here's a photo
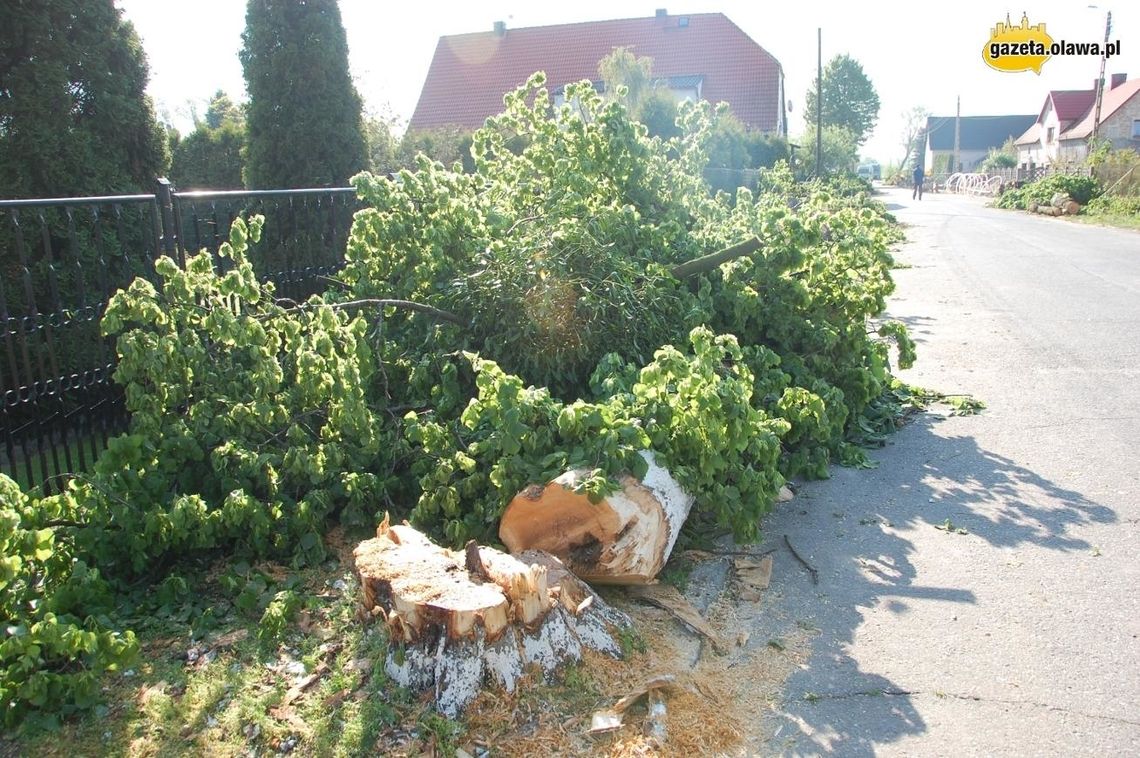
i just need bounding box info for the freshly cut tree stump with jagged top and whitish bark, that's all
[353,519,632,718]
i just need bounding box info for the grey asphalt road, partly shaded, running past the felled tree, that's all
[760,185,1140,756]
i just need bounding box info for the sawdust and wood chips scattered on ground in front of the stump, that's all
[466,594,809,758]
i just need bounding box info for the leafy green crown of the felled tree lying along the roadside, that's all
[0,75,913,722]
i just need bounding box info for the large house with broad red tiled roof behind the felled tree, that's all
[408,10,788,135]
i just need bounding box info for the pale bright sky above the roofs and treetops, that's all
[116,0,1140,164]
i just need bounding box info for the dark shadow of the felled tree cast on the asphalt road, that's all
[758,414,1117,756]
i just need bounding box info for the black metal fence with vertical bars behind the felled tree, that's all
[0,180,359,491]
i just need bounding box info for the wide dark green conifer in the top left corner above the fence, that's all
[0,0,169,197]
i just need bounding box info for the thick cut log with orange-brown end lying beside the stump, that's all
[499,451,693,585]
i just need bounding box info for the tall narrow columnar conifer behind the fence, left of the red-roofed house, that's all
[241,0,367,189]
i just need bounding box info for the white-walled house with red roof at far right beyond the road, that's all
[1017,74,1140,168]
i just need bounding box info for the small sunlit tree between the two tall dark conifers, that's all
[170,90,245,189]
